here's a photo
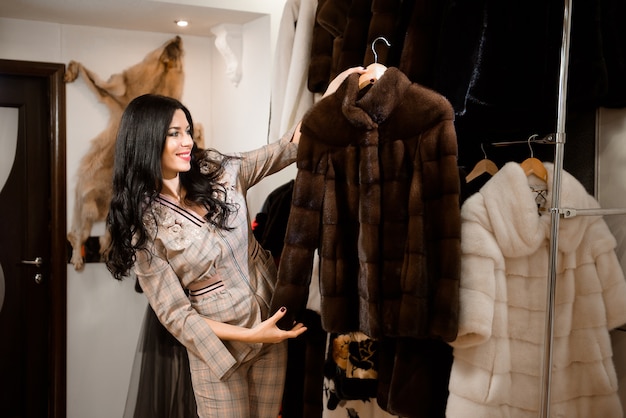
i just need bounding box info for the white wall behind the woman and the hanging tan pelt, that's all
[0,10,282,418]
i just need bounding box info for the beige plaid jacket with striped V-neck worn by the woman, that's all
[134,129,297,379]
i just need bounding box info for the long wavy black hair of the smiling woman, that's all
[106,94,237,280]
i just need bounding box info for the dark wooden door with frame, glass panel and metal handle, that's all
[0,60,67,418]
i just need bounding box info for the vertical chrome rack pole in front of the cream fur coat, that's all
[540,0,572,418]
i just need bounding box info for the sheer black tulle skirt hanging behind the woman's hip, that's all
[124,305,198,418]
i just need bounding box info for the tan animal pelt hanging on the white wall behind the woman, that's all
[65,36,184,270]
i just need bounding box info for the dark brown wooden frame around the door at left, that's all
[0,59,67,418]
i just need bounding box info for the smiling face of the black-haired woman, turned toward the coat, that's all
[161,109,193,180]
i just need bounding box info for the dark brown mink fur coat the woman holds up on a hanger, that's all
[272,67,460,417]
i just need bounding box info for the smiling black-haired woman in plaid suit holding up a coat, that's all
[107,67,363,417]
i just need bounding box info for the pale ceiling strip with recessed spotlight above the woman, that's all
[0,0,266,36]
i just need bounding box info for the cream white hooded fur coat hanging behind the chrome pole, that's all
[446,162,626,418]
